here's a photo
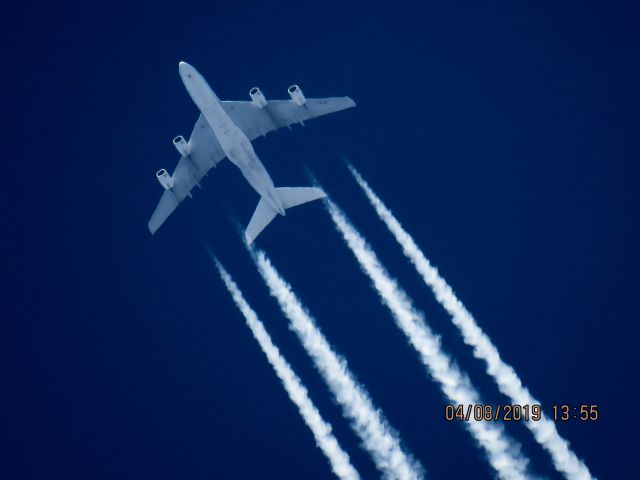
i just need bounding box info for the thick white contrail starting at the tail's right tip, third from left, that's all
[326,200,528,479]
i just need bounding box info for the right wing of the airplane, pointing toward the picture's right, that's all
[220,97,356,140]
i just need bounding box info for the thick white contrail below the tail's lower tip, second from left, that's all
[253,251,424,480]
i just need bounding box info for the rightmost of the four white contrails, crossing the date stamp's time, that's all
[348,165,592,480]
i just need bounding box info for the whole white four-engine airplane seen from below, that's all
[148,62,356,245]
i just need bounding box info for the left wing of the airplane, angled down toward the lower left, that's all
[149,115,225,233]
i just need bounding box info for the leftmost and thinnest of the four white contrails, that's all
[214,258,360,480]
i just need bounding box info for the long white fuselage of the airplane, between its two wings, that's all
[180,62,285,215]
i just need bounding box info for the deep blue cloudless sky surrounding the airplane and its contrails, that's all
[0,1,640,479]
